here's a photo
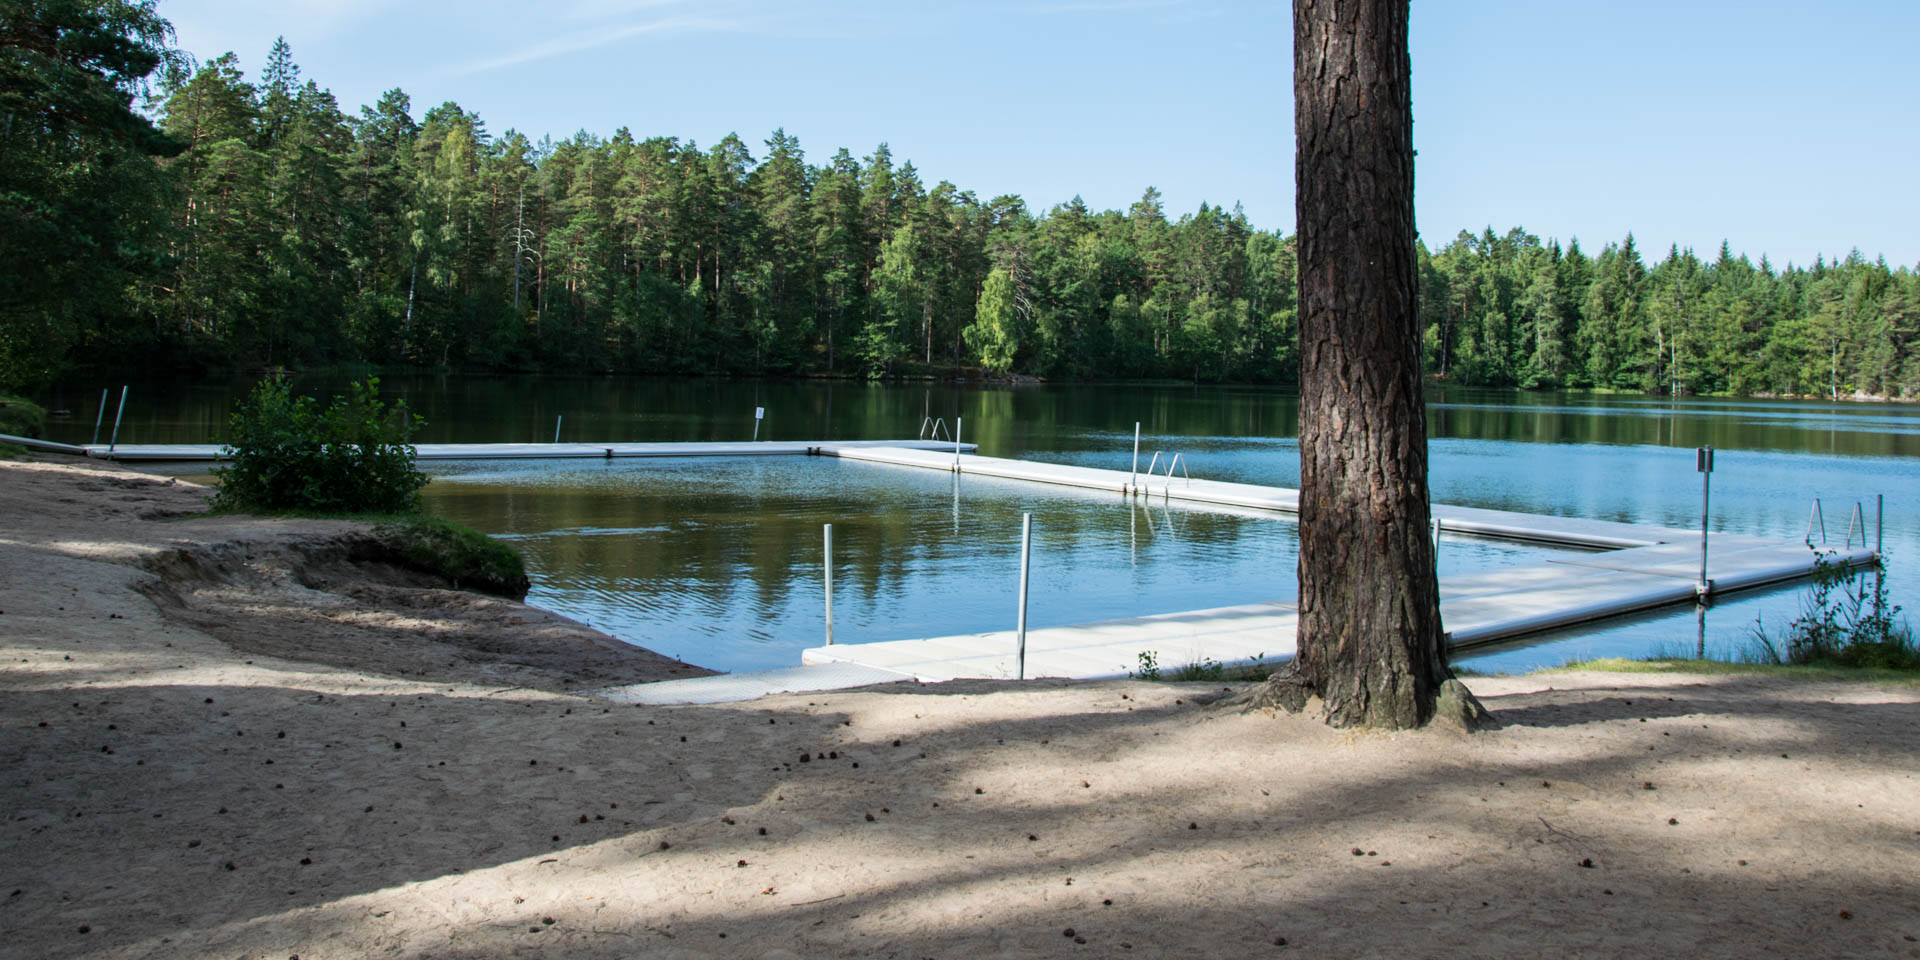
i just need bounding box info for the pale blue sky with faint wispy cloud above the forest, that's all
[159,0,1920,267]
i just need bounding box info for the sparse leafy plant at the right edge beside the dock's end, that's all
[1753,553,1920,670]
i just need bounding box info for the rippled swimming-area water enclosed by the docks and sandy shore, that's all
[428,457,1589,670]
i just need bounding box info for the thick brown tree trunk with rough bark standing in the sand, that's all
[1254,0,1443,728]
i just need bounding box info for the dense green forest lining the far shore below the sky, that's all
[0,0,1920,397]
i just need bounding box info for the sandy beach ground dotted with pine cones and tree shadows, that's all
[0,461,1920,960]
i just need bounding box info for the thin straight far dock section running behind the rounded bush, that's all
[61,440,977,461]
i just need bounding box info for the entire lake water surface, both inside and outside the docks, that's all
[42,376,1920,670]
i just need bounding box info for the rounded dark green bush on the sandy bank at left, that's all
[215,376,426,513]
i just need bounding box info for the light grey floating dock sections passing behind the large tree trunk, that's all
[601,444,1876,703]
